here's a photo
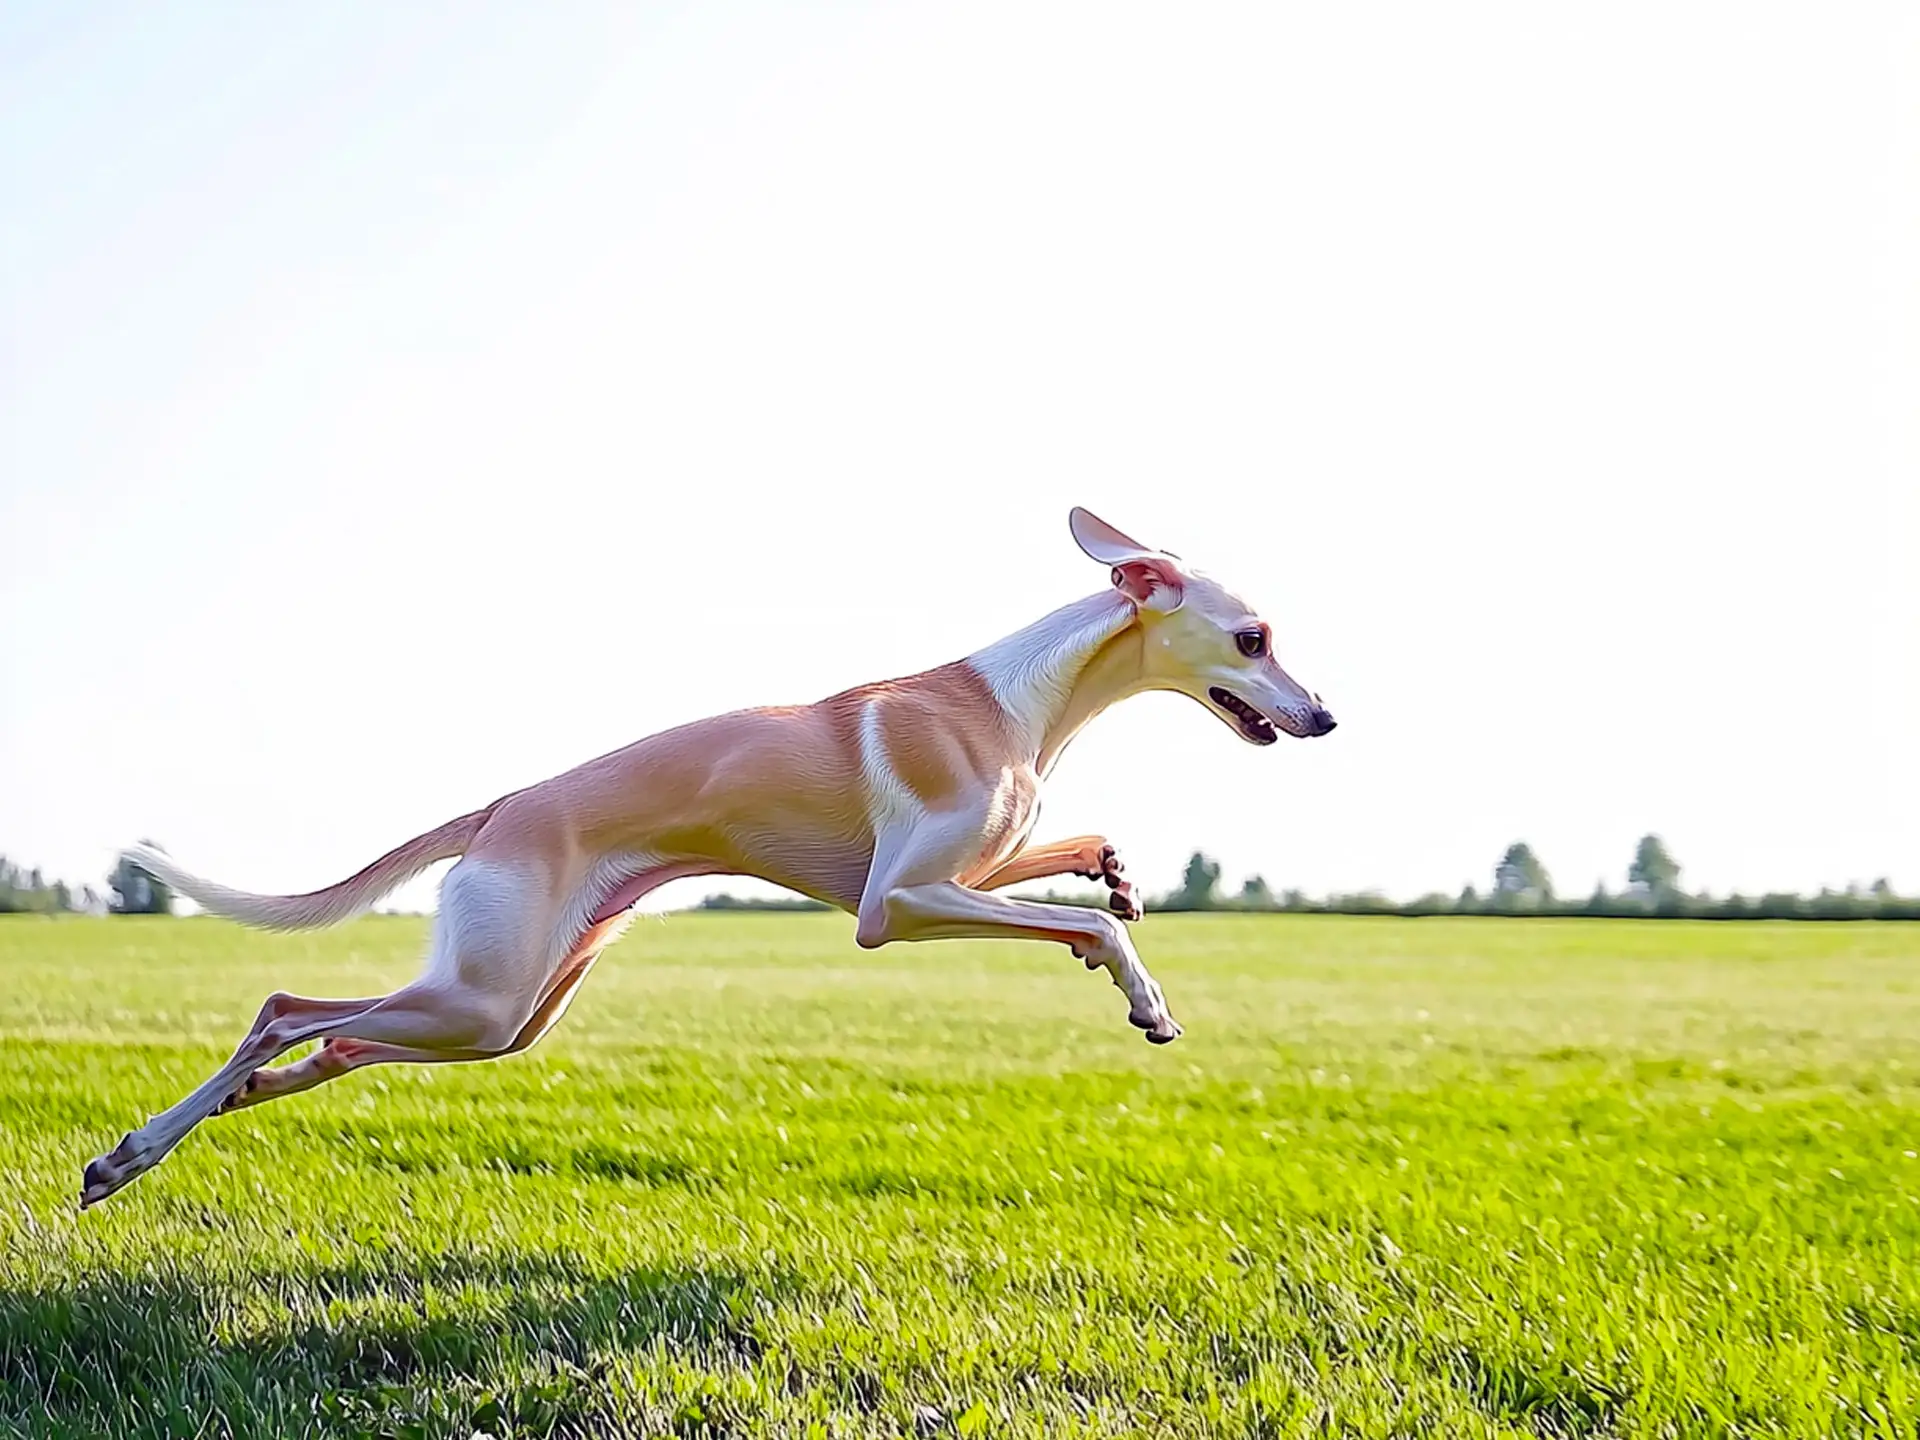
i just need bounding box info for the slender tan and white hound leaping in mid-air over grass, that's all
[81,509,1334,1210]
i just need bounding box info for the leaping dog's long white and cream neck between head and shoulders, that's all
[966,589,1144,776]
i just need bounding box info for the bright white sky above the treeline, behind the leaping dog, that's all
[0,2,1920,904]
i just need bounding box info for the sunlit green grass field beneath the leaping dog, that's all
[0,916,1920,1440]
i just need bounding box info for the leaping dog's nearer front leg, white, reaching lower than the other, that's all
[858,872,1181,1044]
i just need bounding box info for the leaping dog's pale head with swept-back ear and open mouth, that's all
[1068,505,1332,745]
